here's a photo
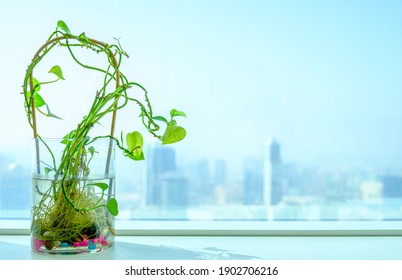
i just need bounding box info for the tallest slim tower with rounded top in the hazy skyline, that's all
[264,140,283,205]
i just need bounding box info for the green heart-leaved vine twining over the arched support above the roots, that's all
[22,21,186,243]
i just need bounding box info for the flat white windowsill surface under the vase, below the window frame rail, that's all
[0,235,402,260]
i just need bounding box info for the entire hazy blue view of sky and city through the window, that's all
[0,0,402,221]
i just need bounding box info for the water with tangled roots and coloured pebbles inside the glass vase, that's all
[31,176,115,254]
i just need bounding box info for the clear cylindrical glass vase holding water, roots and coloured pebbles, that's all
[31,138,117,255]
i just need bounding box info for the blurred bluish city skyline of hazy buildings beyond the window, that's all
[0,141,402,220]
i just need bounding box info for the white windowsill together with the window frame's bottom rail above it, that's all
[0,220,402,260]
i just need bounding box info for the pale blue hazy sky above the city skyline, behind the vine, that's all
[0,0,402,173]
